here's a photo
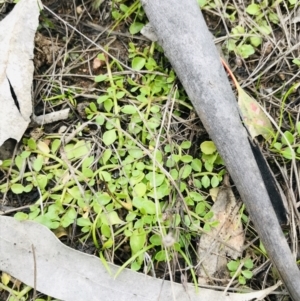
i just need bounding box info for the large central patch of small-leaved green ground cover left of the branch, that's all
[0,36,224,281]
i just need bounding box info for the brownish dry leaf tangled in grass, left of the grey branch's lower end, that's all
[198,176,245,284]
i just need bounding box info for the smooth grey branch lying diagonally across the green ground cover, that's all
[141,0,300,301]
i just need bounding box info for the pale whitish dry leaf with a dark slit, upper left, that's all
[0,0,41,146]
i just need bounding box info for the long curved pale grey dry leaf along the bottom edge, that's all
[0,216,280,301]
